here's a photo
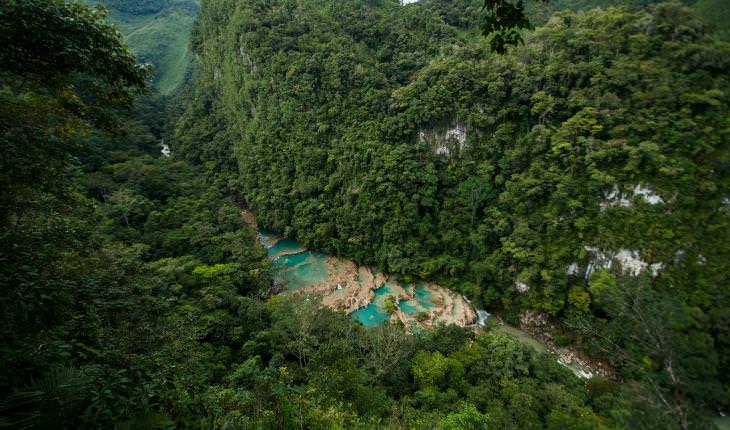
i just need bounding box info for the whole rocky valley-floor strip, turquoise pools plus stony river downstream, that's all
[241,210,616,379]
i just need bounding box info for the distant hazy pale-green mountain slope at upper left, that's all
[86,0,199,95]
